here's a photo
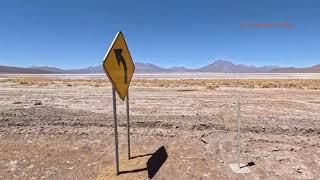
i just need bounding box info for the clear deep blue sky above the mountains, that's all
[0,0,320,69]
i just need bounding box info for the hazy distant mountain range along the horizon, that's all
[0,60,320,74]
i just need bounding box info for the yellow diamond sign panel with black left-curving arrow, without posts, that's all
[103,32,135,100]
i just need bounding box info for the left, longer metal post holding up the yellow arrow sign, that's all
[112,87,119,175]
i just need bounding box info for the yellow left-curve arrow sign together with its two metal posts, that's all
[102,32,135,175]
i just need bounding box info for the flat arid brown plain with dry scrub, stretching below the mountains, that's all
[0,74,320,180]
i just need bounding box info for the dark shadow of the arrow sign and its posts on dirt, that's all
[119,146,168,178]
